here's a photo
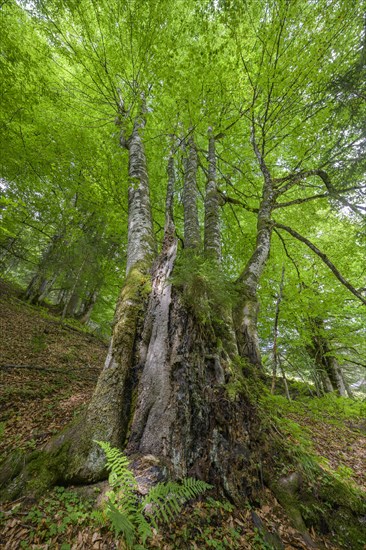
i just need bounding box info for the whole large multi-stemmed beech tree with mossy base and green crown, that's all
[0,0,366,544]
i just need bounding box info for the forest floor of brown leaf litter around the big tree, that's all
[0,281,366,550]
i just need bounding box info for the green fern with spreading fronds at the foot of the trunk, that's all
[96,441,212,550]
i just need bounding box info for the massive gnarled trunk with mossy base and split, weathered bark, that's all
[1,125,257,502]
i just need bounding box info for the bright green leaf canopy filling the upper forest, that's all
[0,0,366,383]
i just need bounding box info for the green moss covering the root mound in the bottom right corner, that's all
[260,390,366,549]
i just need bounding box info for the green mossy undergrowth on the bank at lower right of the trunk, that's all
[260,390,366,550]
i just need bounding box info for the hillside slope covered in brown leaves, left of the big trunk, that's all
[0,281,107,466]
